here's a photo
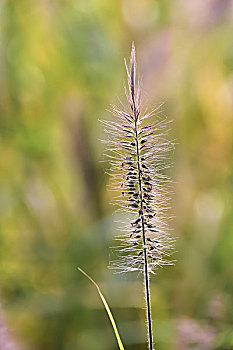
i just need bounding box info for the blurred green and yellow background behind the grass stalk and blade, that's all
[0,0,233,350]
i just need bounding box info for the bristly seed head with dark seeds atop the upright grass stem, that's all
[102,44,173,273]
